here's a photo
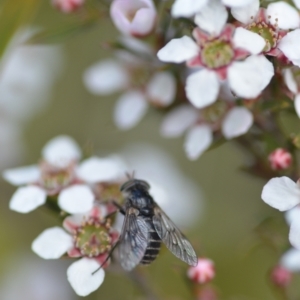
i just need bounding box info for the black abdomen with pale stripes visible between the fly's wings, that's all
[140,218,161,265]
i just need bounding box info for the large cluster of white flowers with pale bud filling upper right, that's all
[79,0,300,160]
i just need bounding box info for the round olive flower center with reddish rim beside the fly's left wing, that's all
[74,219,112,257]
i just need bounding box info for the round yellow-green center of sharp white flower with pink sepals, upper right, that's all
[201,39,234,69]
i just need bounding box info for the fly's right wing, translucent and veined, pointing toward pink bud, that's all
[153,206,198,266]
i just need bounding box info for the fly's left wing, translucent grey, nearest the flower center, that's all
[119,208,149,271]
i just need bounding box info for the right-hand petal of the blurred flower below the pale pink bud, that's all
[146,72,176,106]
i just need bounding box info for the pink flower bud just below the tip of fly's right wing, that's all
[187,258,215,284]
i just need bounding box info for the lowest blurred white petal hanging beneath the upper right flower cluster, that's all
[184,125,213,160]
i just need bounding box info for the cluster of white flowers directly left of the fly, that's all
[3,136,124,296]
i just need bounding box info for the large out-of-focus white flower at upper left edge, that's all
[0,29,62,122]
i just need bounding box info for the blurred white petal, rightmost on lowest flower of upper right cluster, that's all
[222,107,253,139]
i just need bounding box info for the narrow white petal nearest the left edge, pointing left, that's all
[3,165,40,185]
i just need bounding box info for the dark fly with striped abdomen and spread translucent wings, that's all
[118,178,198,271]
